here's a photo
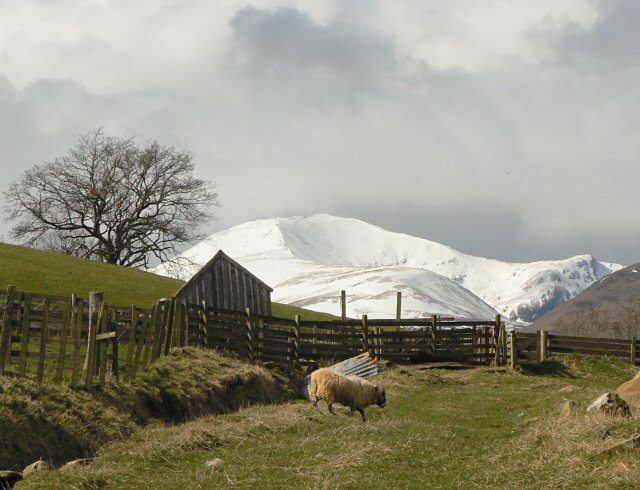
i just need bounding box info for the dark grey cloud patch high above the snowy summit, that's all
[230,7,399,103]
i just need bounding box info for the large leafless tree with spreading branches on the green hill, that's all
[4,130,219,267]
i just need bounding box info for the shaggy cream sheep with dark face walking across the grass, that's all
[309,368,387,422]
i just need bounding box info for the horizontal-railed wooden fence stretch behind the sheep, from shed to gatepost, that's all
[198,305,501,364]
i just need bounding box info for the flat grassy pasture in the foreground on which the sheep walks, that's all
[18,357,640,489]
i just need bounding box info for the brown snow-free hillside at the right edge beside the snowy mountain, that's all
[528,263,640,337]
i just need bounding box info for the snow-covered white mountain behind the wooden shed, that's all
[154,215,622,323]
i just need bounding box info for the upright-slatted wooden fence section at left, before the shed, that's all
[0,287,187,389]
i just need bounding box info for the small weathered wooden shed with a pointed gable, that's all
[176,250,273,316]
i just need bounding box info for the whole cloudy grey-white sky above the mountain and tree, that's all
[0,0,640,265]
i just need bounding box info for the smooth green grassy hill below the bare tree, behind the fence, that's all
[0,243,336,320]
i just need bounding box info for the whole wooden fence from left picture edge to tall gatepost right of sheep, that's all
[0,286,504,389]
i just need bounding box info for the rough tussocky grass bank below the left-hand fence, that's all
[0,349,284,470]
